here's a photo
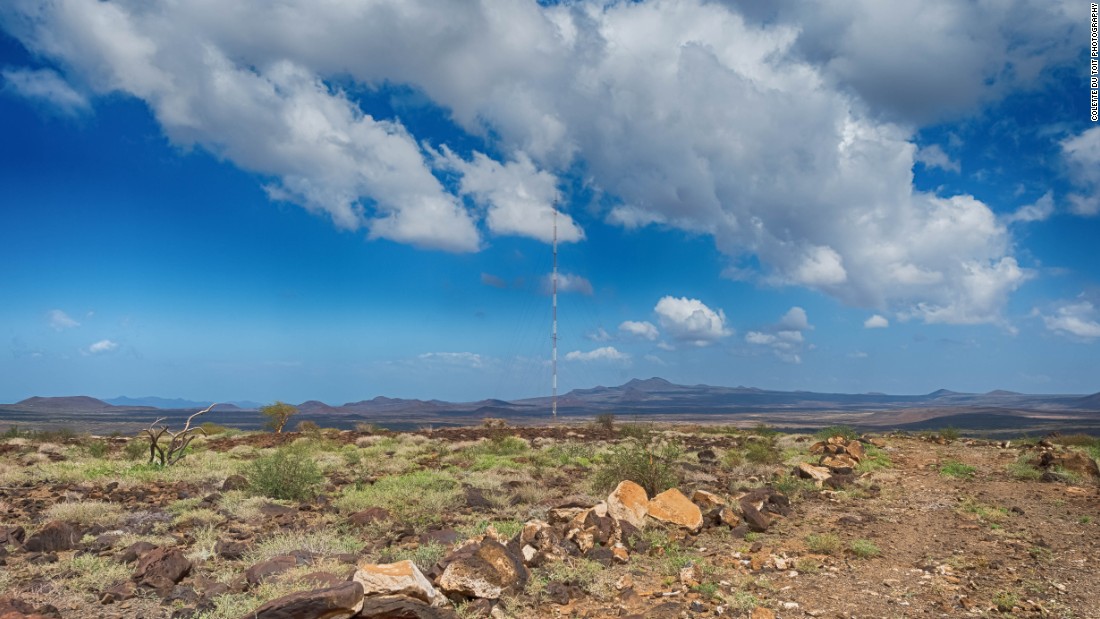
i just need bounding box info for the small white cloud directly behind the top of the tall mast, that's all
[437,146,584,243]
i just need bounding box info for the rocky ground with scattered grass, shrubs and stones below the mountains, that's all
[0,423,1100,619]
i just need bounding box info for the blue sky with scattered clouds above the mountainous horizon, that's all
[0,0,1100,404]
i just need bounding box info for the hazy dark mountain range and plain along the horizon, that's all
[0,377,1100,427]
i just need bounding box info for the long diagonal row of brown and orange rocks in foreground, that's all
[238,482,790,619]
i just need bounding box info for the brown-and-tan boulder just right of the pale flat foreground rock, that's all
[439,540,528,599]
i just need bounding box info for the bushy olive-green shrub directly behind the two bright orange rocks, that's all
[593,441,683,496]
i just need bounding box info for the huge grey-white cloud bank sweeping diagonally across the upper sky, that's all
[2,0,1064,323]
